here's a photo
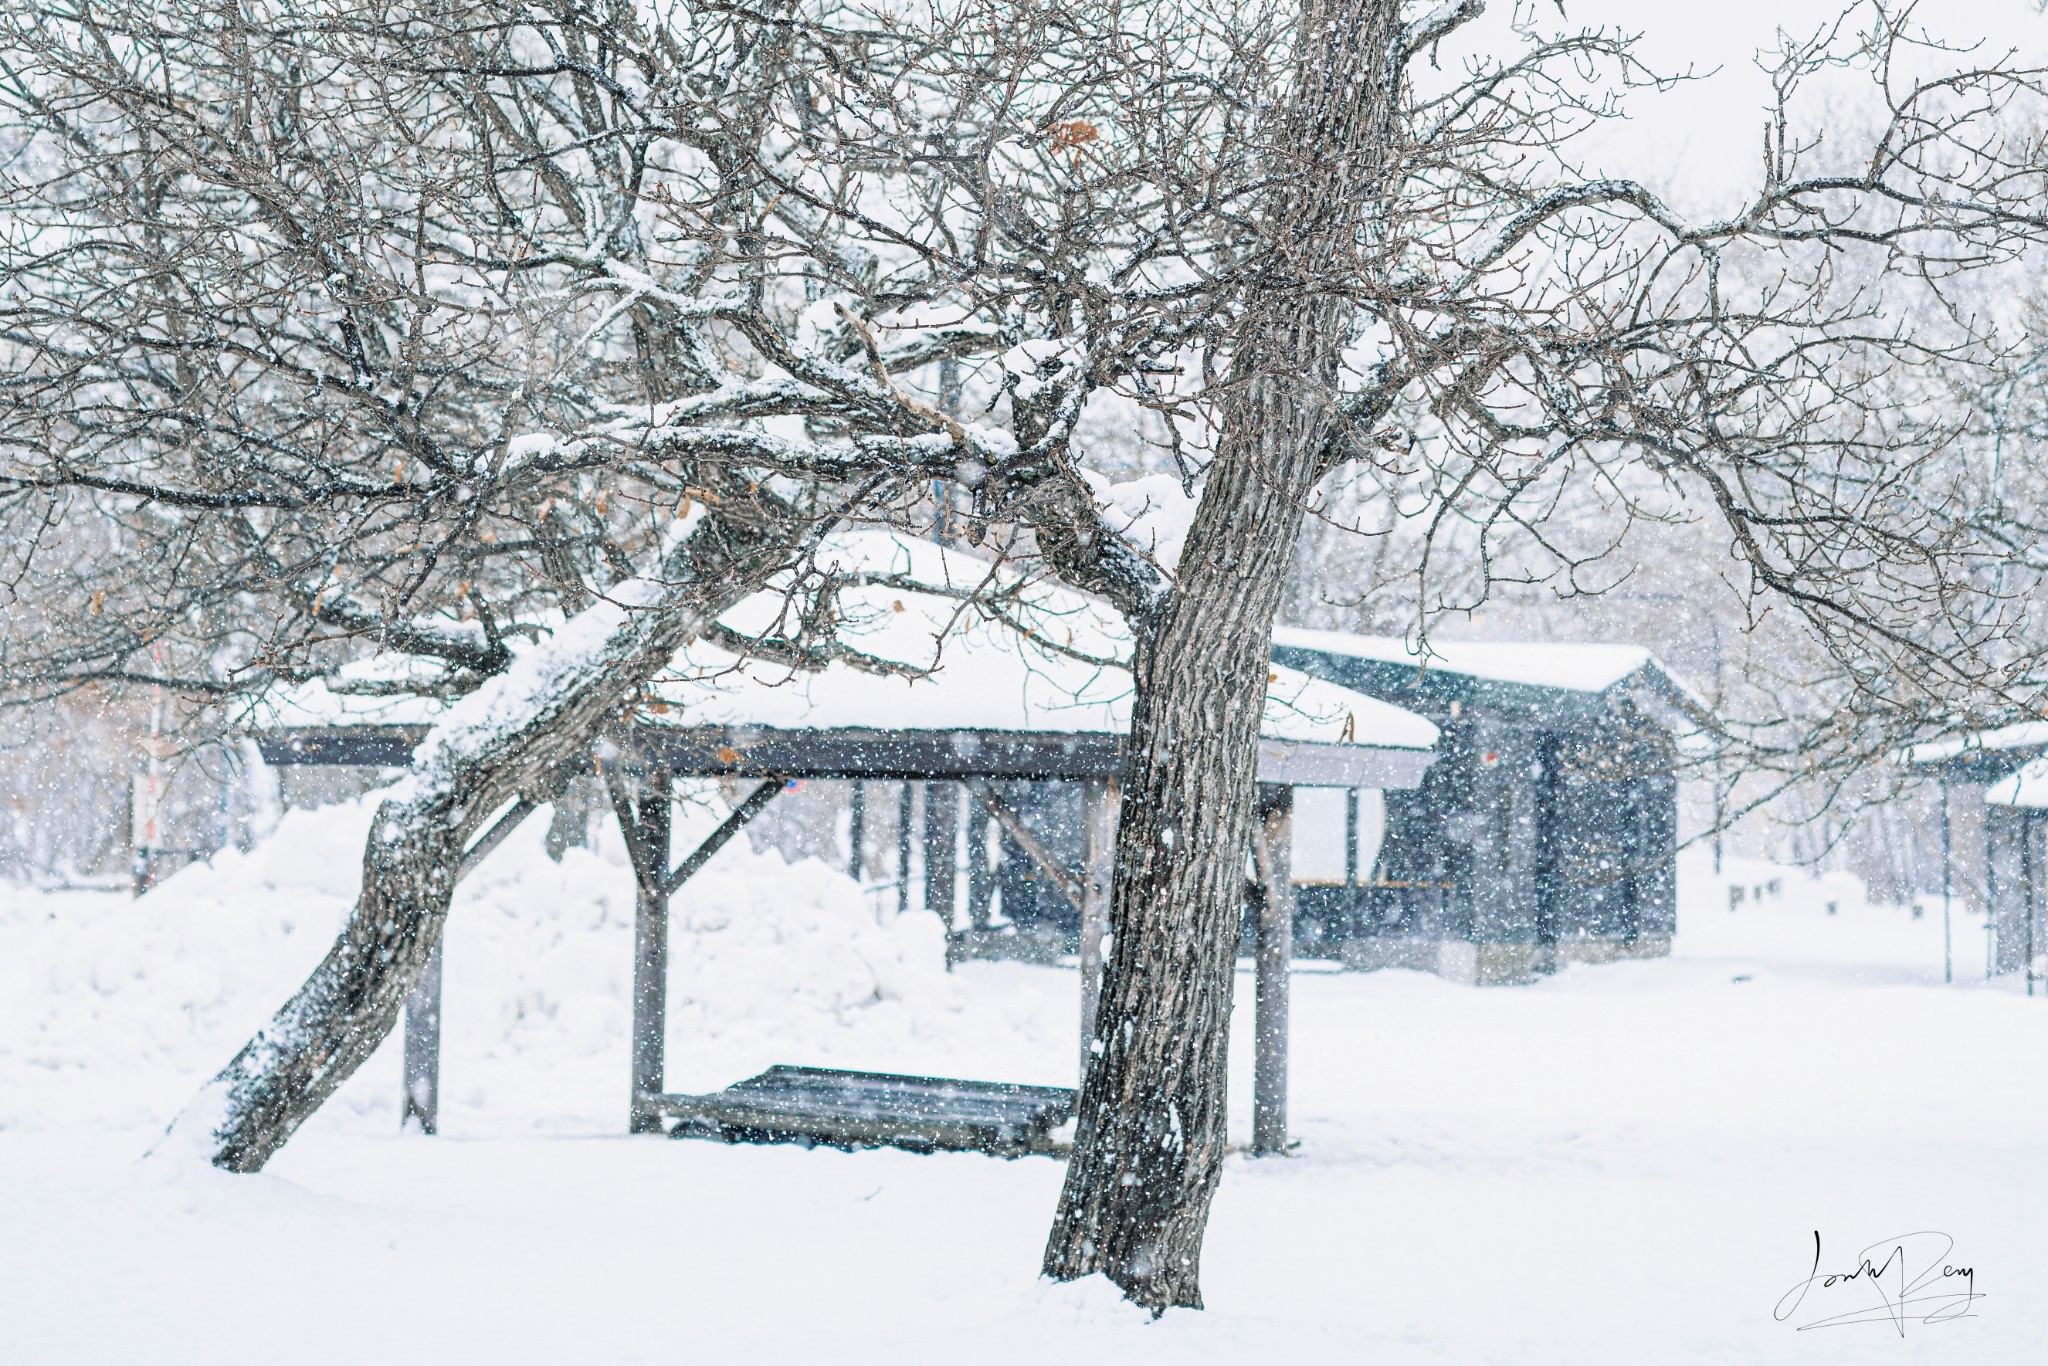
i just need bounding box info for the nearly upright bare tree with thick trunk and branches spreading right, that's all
[1019,0,2048,1309]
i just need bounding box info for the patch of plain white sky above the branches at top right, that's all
[1442,0,2048,213]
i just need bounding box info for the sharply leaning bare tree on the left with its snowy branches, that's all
[0,4,1056,1169]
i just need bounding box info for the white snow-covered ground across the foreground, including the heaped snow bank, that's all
[0,807,2048,1366]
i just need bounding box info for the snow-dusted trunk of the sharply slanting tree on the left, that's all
[172,514,784,1171]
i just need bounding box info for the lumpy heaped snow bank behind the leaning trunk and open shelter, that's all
[0,795,983,1133]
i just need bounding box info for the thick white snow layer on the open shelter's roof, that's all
[256,530,1438,750]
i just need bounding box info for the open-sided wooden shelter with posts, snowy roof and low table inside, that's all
[258,532,1436,1151]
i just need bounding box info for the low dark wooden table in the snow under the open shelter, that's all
[647,1067,1073,1157]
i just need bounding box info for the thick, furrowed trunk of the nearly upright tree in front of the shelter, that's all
[1044,0,1399,1311]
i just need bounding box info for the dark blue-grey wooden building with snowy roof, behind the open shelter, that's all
[1274,629,1700,983]
